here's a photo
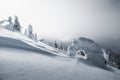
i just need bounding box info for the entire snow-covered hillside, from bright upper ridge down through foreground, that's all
[0,28,120,80]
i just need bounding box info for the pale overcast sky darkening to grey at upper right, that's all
[0,0,120,40]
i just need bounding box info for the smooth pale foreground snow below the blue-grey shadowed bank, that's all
[0,48,120,80]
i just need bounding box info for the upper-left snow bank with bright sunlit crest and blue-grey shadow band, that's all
[0,27,65,56]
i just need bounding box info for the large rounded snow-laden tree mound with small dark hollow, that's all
[67,37,105,66]
